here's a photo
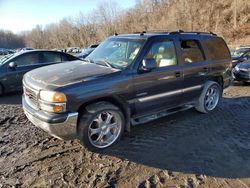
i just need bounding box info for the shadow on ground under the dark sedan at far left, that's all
[0,91,22,105]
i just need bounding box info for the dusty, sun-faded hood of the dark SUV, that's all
[24,61,119,89]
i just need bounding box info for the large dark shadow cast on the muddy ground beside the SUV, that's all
[101,97,250,178]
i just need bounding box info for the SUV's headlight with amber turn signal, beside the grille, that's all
[39,91,67,113]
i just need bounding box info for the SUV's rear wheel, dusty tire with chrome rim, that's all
[195,81,222,113]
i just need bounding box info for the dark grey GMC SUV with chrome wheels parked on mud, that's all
[23,32,231,150]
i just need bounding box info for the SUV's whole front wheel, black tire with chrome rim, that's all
[77,101,125,151]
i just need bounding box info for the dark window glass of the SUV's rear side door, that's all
[181,40,205,64]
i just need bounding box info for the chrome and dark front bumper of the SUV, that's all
[22,97,78,140]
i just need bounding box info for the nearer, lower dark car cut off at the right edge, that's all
[232,60,250,83]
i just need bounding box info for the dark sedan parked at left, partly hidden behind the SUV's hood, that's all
[0,50,79,95]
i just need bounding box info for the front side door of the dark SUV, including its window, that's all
[133,38,183,116]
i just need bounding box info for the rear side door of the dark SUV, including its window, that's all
[180,36,210,103]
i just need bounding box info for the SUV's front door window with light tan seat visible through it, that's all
[146,41,177,67]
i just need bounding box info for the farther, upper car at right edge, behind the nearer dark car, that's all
[232,47,250,67]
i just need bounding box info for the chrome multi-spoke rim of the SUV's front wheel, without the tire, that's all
[88,110,122,148]
